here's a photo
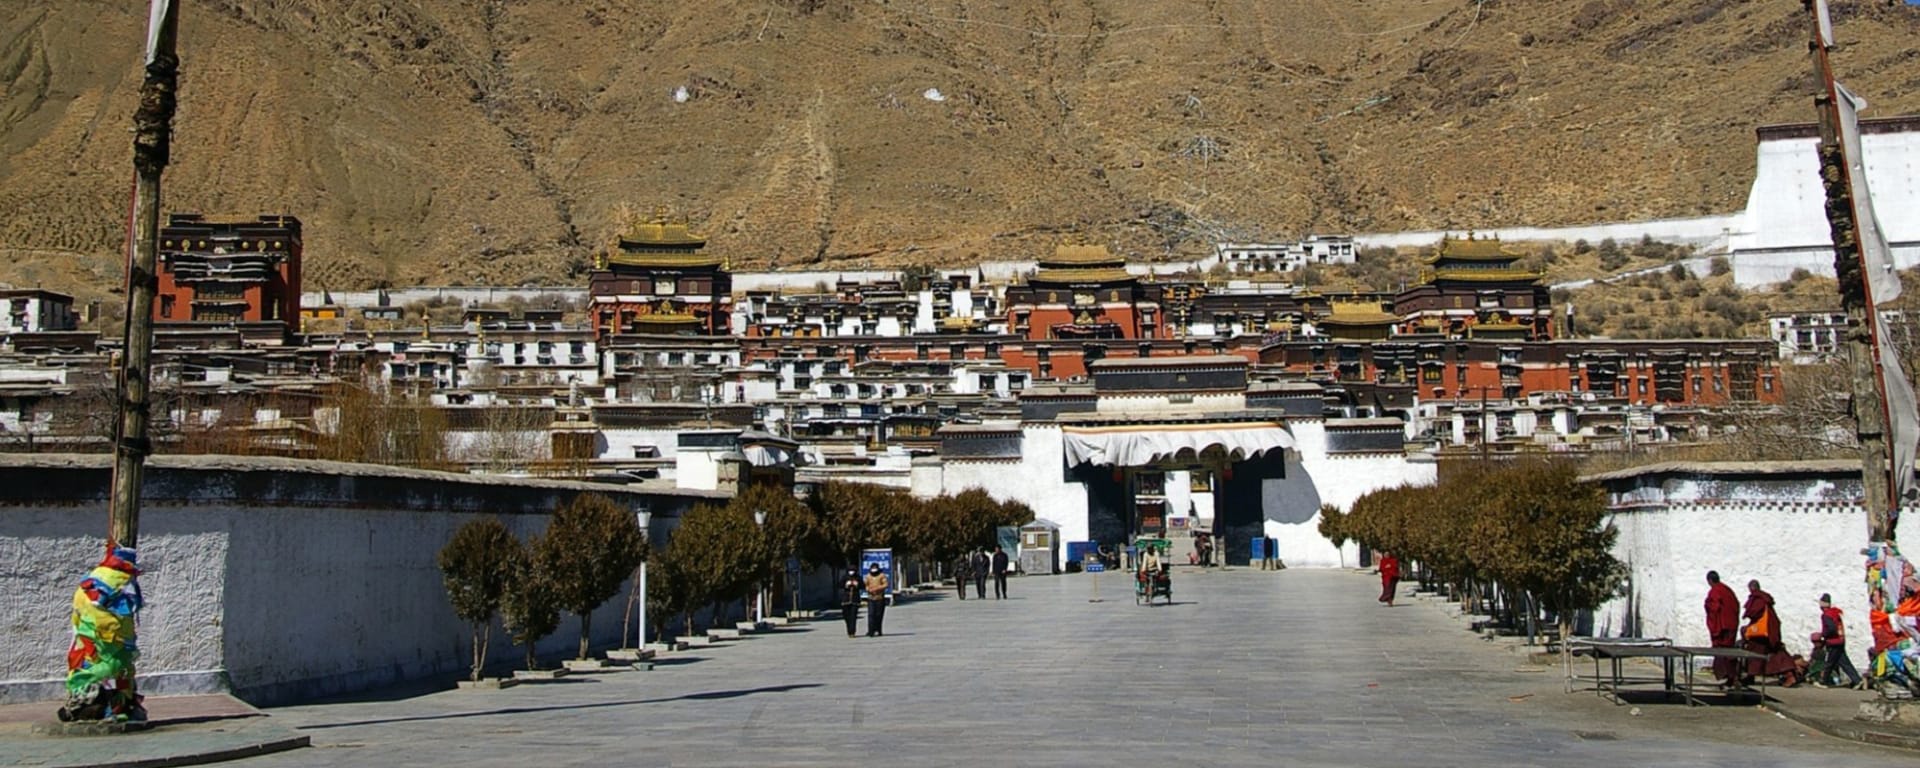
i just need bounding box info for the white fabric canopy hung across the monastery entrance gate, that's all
[1062,420,1294,467]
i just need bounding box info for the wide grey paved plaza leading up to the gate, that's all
[228,568,1912,768]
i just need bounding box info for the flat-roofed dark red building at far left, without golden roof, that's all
[154,213,300,324]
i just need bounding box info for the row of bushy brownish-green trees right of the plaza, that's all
[1319,461,1624,649]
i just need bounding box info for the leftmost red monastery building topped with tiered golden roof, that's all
[588,213,733,338]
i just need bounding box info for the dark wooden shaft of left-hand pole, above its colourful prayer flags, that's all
[108,0,180,547]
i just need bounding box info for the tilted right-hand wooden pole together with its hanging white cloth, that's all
[1803,0,1920,549]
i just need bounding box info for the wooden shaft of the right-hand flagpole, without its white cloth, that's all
[1803,0,1910,543]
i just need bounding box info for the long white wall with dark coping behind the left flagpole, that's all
[0,455,721,703]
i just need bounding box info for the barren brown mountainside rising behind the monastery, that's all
[0,0,1920,307]
